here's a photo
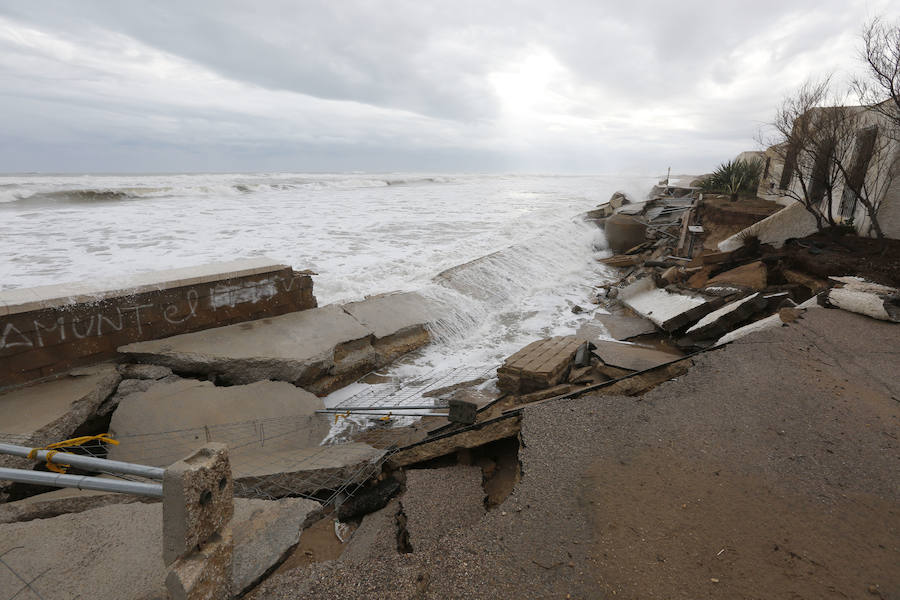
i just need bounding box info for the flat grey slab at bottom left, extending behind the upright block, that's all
[0,498,318,600]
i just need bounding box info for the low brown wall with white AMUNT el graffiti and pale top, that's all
[0,259,316,388]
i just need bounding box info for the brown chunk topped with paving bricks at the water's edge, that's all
[497,336,584,394]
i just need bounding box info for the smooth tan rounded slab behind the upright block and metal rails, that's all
[109,379,329,467]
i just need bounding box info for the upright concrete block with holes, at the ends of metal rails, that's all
[163,443,234,564]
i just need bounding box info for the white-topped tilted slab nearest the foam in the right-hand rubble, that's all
[619,277,717,332]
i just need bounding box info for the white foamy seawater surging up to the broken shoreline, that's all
[0,174,654,398]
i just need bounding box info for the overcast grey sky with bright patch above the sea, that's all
[0,0,900,174]
